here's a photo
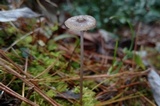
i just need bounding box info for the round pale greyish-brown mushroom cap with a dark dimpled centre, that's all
[65,15,96,31]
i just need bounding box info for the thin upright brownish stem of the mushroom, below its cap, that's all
[80,31,84,106]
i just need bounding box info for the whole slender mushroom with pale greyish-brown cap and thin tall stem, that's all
[65,15,96,106]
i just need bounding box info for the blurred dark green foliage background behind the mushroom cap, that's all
[0,0,160,32]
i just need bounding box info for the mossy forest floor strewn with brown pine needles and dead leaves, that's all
[0,6,159,106]
